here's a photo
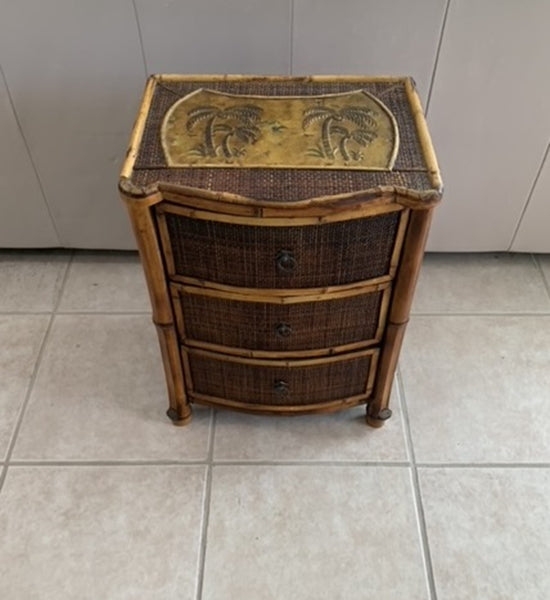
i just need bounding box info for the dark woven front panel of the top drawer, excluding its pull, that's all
[166,212,401,288]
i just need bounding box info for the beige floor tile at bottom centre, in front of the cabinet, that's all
[202,465,428,600]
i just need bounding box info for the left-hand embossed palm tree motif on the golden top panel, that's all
[186,104,263,160]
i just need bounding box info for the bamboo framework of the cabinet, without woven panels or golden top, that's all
[119,75,442,427]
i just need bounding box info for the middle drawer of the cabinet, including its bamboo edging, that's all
[171,284,391,356]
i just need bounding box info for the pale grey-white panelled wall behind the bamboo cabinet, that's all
[0,0,550,252]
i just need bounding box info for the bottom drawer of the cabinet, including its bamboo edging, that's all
[187,349,378,409]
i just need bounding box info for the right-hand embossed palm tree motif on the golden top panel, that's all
[302,106,378,162]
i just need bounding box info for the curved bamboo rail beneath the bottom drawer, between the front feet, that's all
[190,392,368,416]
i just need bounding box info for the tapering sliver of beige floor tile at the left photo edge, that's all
[0,315,50,460]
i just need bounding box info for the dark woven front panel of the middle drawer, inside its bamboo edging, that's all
[180,292,382,352]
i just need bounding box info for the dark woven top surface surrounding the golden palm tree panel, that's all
[132,81,432,202]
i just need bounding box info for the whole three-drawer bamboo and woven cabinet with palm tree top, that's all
[119,75,442,427]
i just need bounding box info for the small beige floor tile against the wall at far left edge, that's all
[0,251,70,312]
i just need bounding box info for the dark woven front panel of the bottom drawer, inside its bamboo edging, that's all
[189,354,371,406]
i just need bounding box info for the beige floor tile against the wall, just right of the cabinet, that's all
[412,254,550,313]
